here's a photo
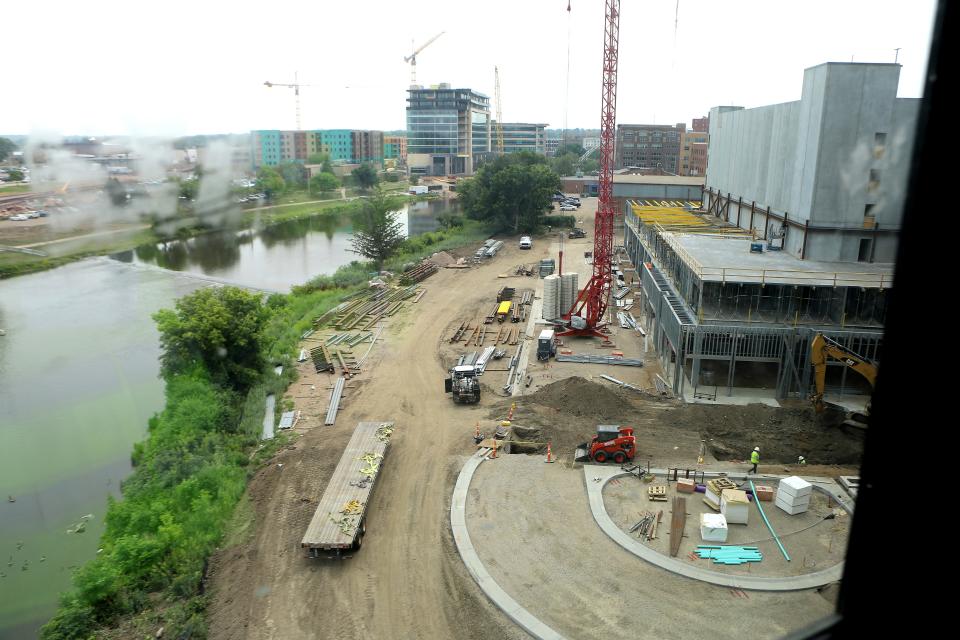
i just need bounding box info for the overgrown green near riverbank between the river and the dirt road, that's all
[42,211,487,640]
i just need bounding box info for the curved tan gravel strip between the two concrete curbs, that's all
[467,455,833,640]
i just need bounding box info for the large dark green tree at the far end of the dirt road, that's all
[457,151,560,233]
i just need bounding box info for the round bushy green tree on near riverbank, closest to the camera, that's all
[153,287,267,391]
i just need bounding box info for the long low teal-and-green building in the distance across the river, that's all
[250,129,383,169]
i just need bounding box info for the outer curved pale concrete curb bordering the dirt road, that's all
[450,449,564,640]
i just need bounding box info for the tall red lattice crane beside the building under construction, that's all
[560,0,620,338]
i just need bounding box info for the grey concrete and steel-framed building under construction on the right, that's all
[624,63,919,401]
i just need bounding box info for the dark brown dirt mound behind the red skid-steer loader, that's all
[489,377,864,466]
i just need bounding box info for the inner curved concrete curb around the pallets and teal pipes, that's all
[583,465,852,591]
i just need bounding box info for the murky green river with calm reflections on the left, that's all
[0,201,456,640]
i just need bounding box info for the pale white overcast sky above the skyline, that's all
[0,0,935,135]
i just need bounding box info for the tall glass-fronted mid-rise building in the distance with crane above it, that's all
[407,83,491,176]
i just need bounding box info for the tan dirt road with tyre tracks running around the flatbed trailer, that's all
[209,238,546,640]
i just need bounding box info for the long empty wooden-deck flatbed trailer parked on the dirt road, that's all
[300,422,393,558]
